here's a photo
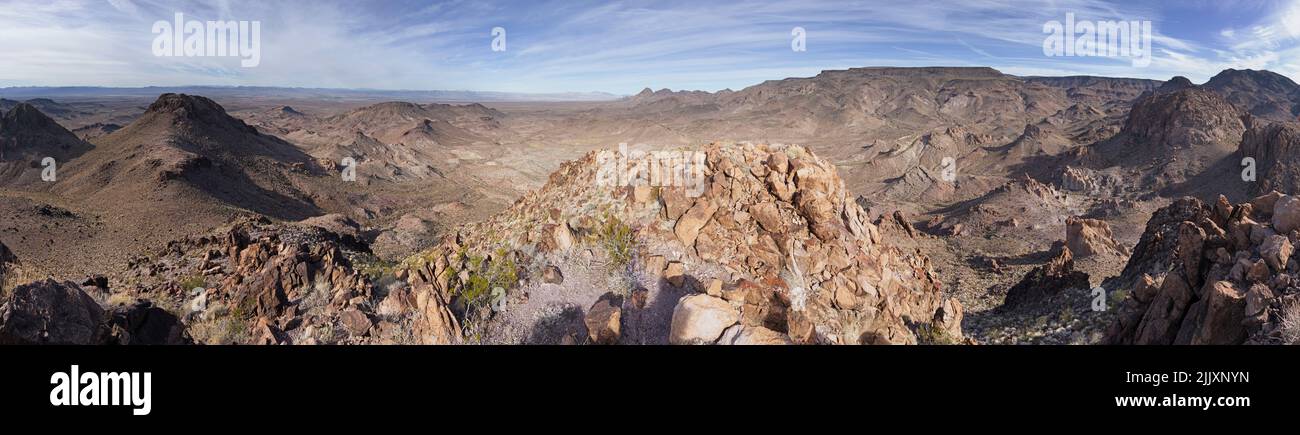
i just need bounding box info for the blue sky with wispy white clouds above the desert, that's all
[0,0,1300,95]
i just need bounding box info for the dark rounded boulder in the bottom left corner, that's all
[0,279,104,344]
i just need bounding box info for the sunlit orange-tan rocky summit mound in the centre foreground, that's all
[407,143,961,344]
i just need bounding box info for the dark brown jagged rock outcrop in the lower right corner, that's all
[1104,193,1300,344]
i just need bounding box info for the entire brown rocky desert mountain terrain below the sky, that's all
[0,68,1300,344]
